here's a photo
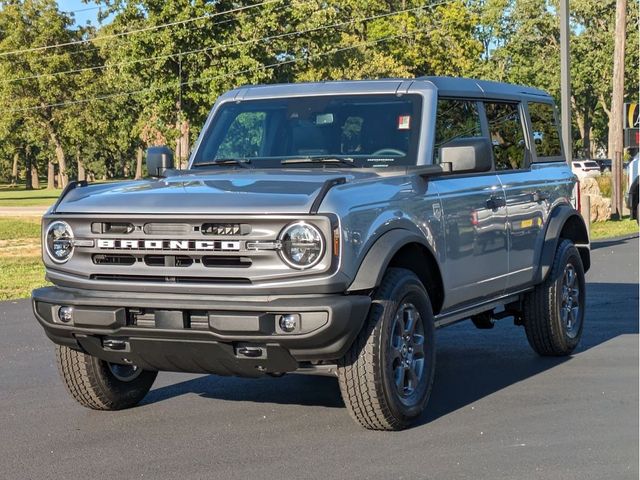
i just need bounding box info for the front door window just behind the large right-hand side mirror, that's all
[435,99,482,161]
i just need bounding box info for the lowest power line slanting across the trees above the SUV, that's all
[5,21,438,113]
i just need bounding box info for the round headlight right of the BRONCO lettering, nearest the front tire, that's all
[279,222,324,269]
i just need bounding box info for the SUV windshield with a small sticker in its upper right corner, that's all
[192,94,421,168]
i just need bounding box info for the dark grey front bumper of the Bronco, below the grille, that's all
[32,287,371,376]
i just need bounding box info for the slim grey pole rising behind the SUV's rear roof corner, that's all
[560,0,573,165]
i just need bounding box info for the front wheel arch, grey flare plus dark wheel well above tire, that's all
[347,229,444,314]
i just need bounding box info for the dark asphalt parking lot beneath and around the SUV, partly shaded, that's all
[0,237,638,480]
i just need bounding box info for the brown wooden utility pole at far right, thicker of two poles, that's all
[609,0,627,218]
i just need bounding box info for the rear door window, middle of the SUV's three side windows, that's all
[485,102,527,170]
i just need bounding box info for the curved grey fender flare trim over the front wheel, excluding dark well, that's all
[347,228,431,292]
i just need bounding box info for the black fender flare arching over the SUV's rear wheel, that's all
[534,204,591,284]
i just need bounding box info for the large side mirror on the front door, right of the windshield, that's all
[440,137,492,172]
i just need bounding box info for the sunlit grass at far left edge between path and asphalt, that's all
[0,217,46,300]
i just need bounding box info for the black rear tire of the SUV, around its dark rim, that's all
[523,239,586,356]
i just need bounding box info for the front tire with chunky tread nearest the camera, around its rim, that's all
[338,268,435,430]
